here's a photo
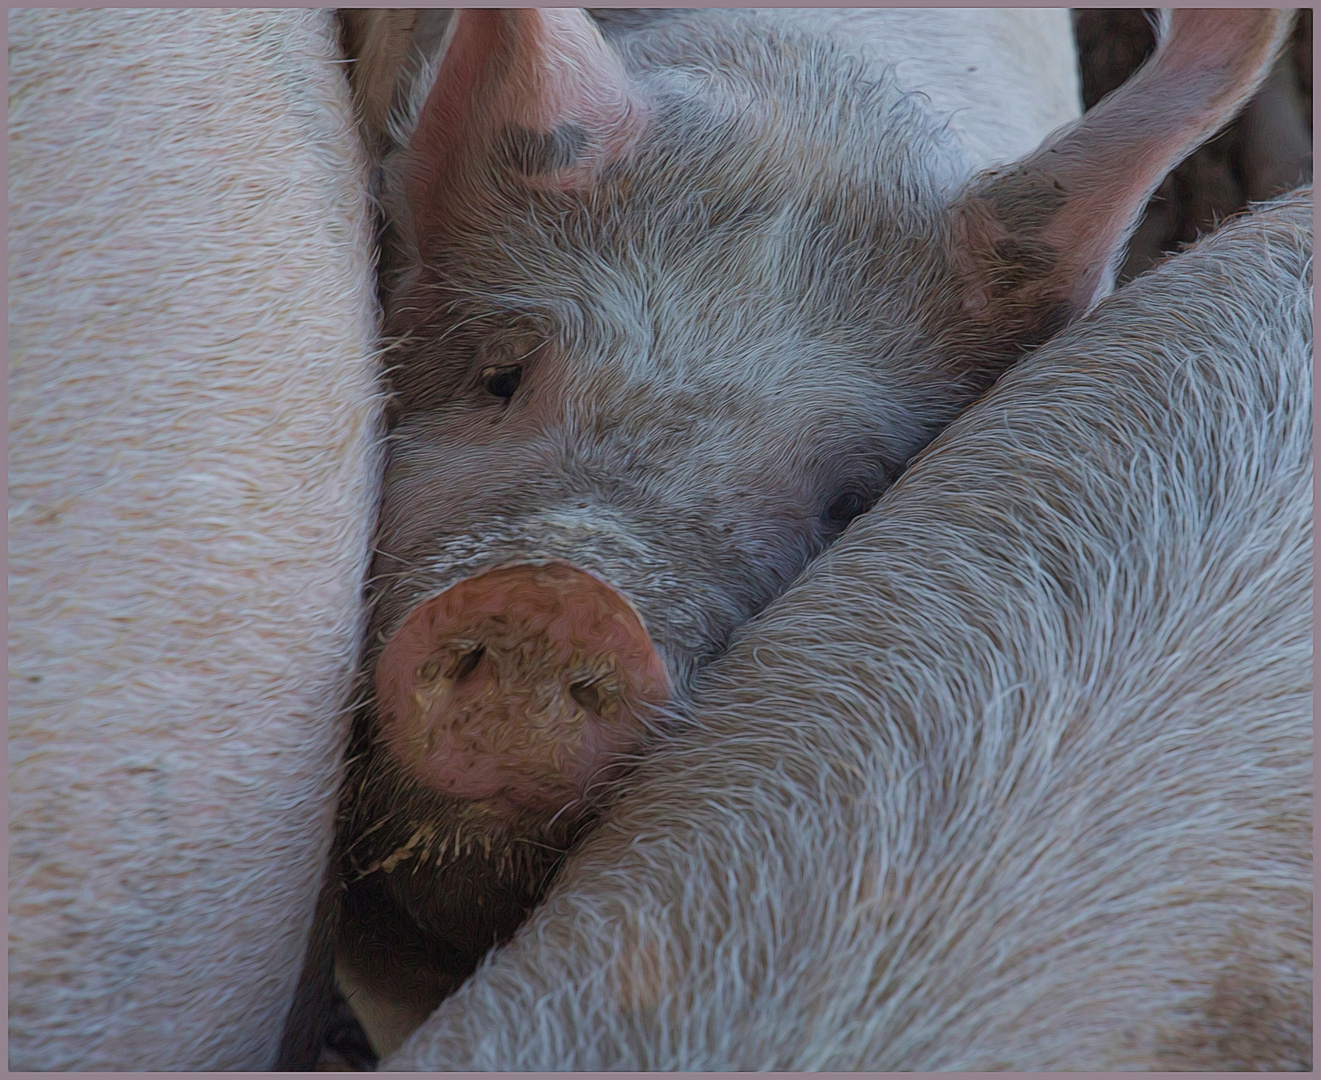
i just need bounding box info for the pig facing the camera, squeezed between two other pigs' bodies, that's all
[302,9,1288,1067]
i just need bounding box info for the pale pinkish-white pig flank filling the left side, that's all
[8,9,383,1071]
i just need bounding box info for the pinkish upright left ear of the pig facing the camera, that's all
[406,8,646,252]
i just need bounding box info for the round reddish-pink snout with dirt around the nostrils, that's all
[376,562,670,811]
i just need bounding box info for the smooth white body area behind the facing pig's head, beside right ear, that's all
[764,8,1082,172]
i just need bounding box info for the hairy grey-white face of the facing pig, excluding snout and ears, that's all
[361,12,995,797]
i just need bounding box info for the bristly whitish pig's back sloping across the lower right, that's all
[382,190,1313,1072]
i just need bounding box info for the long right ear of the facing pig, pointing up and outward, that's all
[954,9,1291,347]
